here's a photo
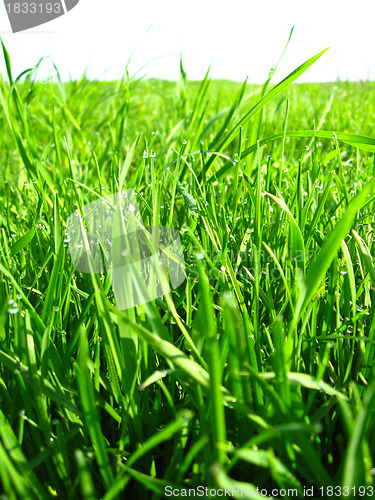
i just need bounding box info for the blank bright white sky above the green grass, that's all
[0,0,375,82]
